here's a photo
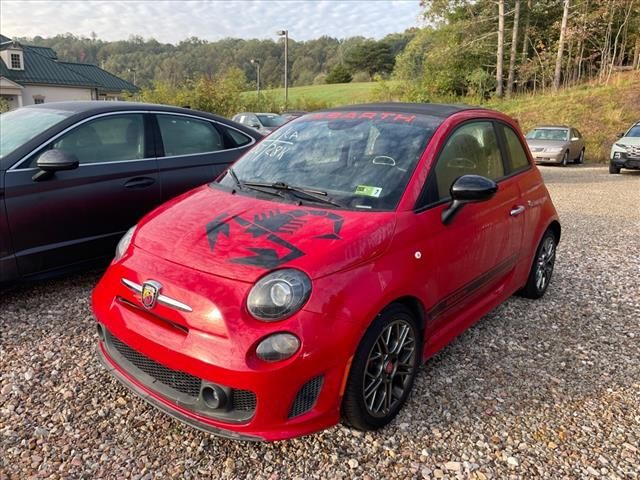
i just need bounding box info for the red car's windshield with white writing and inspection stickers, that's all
[220,111,442,210]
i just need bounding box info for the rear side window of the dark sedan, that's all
[157,115,224,157]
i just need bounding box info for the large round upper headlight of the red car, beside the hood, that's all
[247,268,311,322]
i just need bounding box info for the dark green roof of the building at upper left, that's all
[0,36,138,92]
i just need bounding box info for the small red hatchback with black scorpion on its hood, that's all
[93,103,560,441]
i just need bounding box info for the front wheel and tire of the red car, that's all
[342,304,422,431]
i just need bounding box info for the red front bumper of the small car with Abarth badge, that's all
[93,251,349,441]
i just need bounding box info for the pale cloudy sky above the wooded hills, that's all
[0,0,420,43]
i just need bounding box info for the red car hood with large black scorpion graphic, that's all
[133,186,396,282]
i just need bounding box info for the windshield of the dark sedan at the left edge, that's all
[0,108,73,158]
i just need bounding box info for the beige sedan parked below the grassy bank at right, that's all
[526,125,585,167]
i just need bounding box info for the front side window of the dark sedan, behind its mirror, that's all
[29,114,144,167]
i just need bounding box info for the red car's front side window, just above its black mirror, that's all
[434,122,505,200]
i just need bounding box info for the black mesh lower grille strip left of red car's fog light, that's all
[109,335,202,398]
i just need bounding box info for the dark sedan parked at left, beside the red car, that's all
[0,102,262,284]
